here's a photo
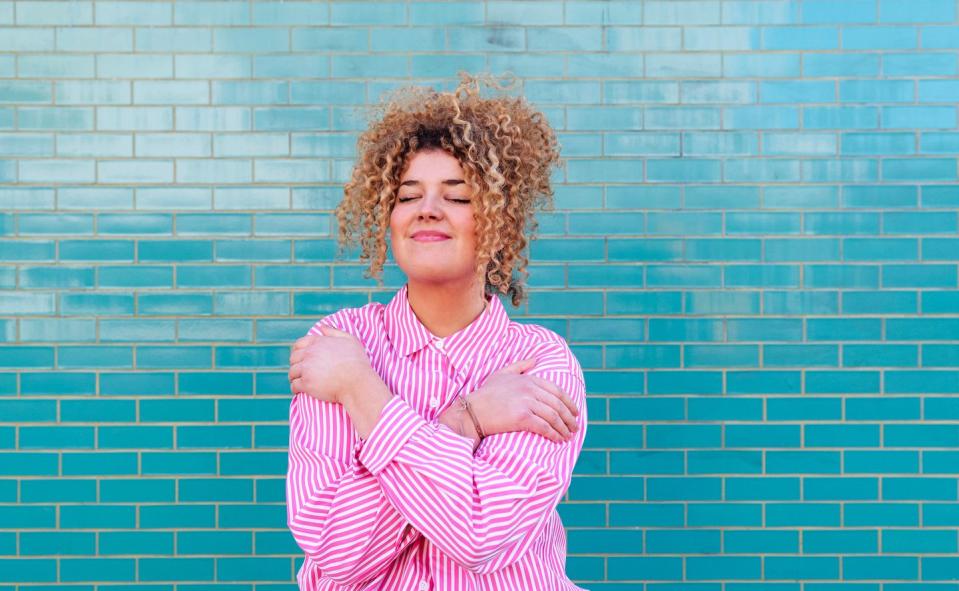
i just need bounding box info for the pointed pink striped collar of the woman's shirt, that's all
[384,285,510,369]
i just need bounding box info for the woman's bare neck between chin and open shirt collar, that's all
[406,279,486,338]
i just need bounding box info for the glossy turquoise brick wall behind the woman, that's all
[0,0,959,591]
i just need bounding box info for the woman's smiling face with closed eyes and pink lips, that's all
[390,150,476,284]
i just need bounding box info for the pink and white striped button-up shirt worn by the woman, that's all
[286,286,586,591]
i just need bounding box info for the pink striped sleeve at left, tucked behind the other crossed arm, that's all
[286,318,422,585]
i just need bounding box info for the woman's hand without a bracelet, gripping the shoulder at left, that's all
[289,324,373,403]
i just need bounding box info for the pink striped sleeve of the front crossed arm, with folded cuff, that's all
[358,343,587,574]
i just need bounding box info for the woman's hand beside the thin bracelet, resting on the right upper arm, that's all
[463,359,579,442]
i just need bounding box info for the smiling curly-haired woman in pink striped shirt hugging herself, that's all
[287,74,586,591]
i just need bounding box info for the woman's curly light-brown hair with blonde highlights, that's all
[336,72,560,306]
